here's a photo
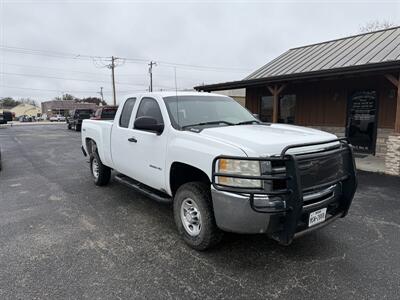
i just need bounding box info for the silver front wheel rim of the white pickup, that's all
[181,198,201,236]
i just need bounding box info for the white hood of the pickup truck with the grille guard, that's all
[200,124,337,156]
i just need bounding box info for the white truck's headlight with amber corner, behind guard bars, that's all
[216,158,263,189]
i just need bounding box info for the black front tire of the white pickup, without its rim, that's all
[174,182,223,251]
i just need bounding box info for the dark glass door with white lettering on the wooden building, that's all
[347,90,377,153]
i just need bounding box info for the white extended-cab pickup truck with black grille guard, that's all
[82,92,357,250]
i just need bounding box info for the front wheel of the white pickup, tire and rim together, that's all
[174,182,222,251]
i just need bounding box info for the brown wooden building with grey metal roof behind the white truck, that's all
[195,27,400,174]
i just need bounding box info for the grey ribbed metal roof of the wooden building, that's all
[245,27,400,80]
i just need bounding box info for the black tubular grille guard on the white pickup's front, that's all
[211,138,357,244]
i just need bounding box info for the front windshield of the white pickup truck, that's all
[164,95,259,129]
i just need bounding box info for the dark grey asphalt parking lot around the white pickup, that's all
[0,125,400,299]
